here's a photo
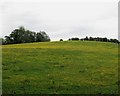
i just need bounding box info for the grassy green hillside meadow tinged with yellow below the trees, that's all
[2,41,119,94]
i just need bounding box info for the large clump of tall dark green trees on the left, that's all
[0,26,50,45]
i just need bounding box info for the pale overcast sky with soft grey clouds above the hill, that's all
[0,0,119,41]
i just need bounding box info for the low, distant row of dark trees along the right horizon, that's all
[68,36,120,44]
